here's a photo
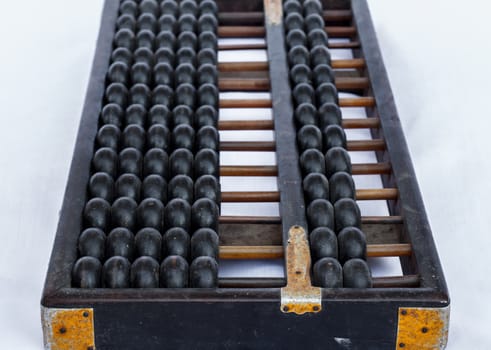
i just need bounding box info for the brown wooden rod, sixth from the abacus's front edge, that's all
[220,139,385,152]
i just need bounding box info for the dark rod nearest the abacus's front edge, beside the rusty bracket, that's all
[218,275,420,288]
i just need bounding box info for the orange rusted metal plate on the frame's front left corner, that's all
[41,307,95,350]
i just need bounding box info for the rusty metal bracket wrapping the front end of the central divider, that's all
[281,226,322,315]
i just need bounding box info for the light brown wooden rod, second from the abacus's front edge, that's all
[220,243,412,259]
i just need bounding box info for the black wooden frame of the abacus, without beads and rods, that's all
[41,0,450,349]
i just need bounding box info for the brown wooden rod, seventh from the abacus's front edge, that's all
[218,118,380,130]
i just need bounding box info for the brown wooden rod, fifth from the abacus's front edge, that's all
[220,163,391,176]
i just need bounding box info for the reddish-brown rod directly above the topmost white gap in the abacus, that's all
[218,26,356,38]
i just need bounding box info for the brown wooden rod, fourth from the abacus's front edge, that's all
[222,188,399,203]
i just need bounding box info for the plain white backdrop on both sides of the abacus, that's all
[0,0,491,350]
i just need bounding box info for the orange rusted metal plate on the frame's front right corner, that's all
[396,306,450,350]
